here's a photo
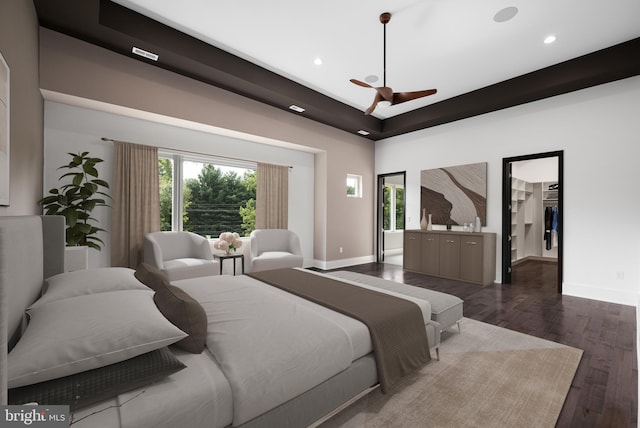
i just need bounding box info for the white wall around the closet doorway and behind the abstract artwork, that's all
[375,77,640,305]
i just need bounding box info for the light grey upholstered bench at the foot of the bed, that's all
[327,270,463,332]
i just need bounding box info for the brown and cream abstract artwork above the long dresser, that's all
[420,162,487,226]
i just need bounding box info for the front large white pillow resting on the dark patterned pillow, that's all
[7,290,187,388]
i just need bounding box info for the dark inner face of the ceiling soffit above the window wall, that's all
[99,0,382,137]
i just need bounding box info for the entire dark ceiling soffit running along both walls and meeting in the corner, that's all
[34,0,640,140]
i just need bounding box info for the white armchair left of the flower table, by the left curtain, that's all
[144,232,220,281]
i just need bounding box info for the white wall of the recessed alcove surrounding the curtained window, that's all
[44,101,314,267]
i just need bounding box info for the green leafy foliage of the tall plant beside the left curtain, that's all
[40,152,111,251]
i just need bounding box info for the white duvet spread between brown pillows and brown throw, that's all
[174,276,356,425]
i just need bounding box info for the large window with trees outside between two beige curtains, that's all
[158,153,256,238]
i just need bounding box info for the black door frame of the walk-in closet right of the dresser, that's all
[502,150,564,294]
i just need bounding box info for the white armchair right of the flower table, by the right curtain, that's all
[250,229,302,272]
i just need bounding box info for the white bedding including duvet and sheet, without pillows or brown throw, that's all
[67,273,431,428]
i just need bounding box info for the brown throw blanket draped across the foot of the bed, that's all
[248,268,431,393]
